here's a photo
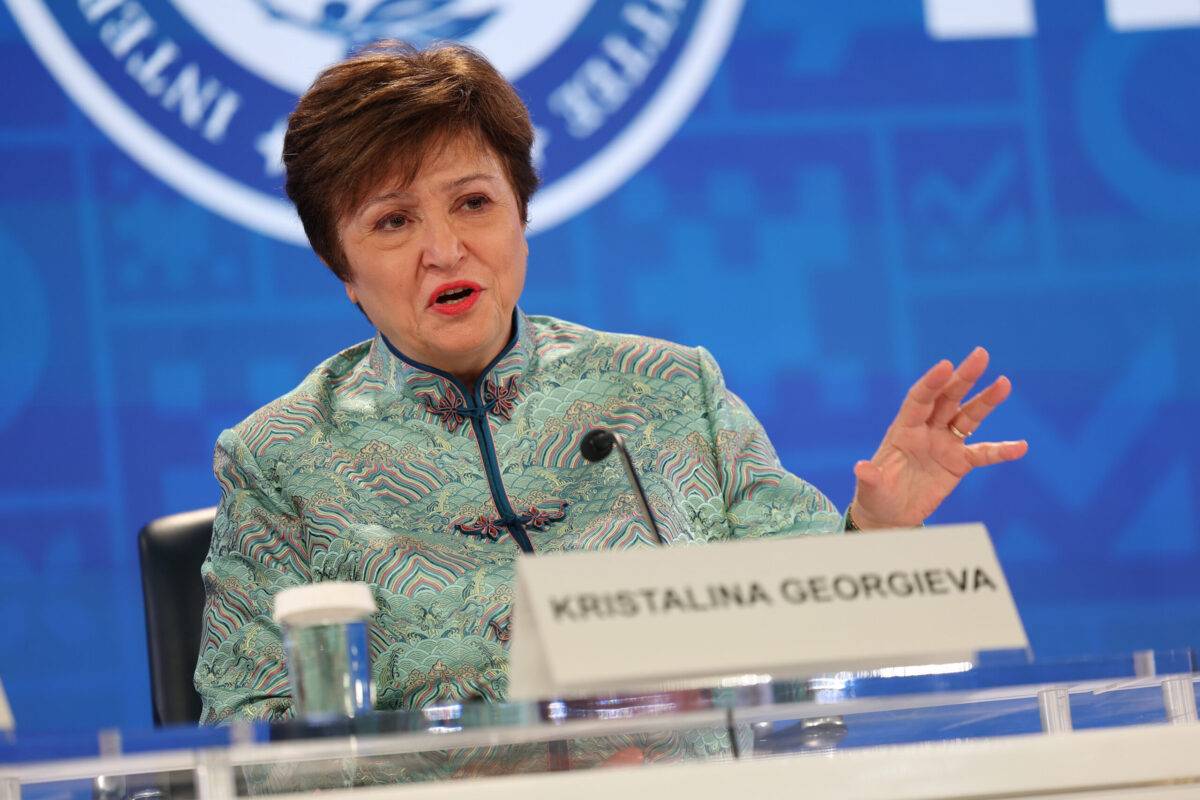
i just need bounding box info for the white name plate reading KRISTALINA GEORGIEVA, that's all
[509,523,1028,699]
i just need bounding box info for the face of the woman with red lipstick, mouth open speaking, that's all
[338,137,529,384]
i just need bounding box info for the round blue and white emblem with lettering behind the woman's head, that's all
[5,0,743,243]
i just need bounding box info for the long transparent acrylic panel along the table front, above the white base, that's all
[0,650,1196,800]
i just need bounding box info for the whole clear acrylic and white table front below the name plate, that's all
[0,650,1200,800]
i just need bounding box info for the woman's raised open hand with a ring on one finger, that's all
[850,347,1030,530]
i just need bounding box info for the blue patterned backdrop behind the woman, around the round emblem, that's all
[0,0,1200,729]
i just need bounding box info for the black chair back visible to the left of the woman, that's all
[138,507,216,726]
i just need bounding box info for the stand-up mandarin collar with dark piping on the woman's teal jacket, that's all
[371,308,534,429]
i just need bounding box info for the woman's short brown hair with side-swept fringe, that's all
[283,41,538,281]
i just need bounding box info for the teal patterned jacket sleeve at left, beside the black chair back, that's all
[196,431,310,722]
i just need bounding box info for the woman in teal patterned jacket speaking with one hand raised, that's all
[196,44,1026,721]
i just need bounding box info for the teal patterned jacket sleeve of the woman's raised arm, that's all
[698,348,844,539]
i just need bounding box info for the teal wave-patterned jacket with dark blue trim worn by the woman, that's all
[196,311,841,722]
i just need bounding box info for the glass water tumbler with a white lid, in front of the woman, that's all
[275,582,376,718]
